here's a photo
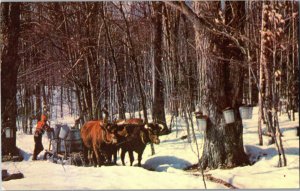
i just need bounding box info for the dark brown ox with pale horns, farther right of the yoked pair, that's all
[117,123,161,166]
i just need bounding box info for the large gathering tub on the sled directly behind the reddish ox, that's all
[66,128,82,152]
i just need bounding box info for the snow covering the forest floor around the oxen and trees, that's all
[2,108,300,190]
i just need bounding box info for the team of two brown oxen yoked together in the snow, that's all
[80,118,163,167]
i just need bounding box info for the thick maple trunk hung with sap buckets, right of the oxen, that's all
[198,2,249,169]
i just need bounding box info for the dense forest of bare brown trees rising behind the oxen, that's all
[1,0,299,169]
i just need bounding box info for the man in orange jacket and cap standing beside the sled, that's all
[32,115,53,160]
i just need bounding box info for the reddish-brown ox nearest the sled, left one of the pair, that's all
[80,120,117,167]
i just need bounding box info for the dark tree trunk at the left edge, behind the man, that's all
[1,3,20,154]
